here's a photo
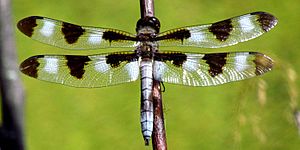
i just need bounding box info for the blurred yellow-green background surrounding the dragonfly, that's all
[12,0,300,150]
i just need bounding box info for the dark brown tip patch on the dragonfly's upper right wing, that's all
[251,12,277,32]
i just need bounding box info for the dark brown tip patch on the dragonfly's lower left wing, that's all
[20,55,44,78]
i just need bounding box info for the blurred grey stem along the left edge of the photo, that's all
[0,0,24,150]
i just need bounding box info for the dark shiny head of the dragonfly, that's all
[136,16,160,34]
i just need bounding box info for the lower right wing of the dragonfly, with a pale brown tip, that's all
[153,52,273,86]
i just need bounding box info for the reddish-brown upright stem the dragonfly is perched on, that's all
[140,0,167,150]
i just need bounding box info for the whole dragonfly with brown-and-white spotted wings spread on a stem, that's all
[17,12,278,145]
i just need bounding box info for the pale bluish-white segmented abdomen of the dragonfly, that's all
[141,61,153,145]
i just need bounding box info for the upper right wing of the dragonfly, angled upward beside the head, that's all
[157,12,277,48]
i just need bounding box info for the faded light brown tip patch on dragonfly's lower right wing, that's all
[250,52,274,75]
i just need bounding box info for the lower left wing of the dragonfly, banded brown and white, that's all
[20,52,139,88]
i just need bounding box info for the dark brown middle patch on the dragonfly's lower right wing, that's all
[202,53,227,77]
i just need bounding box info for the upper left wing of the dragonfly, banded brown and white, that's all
[17,16,136,49]
